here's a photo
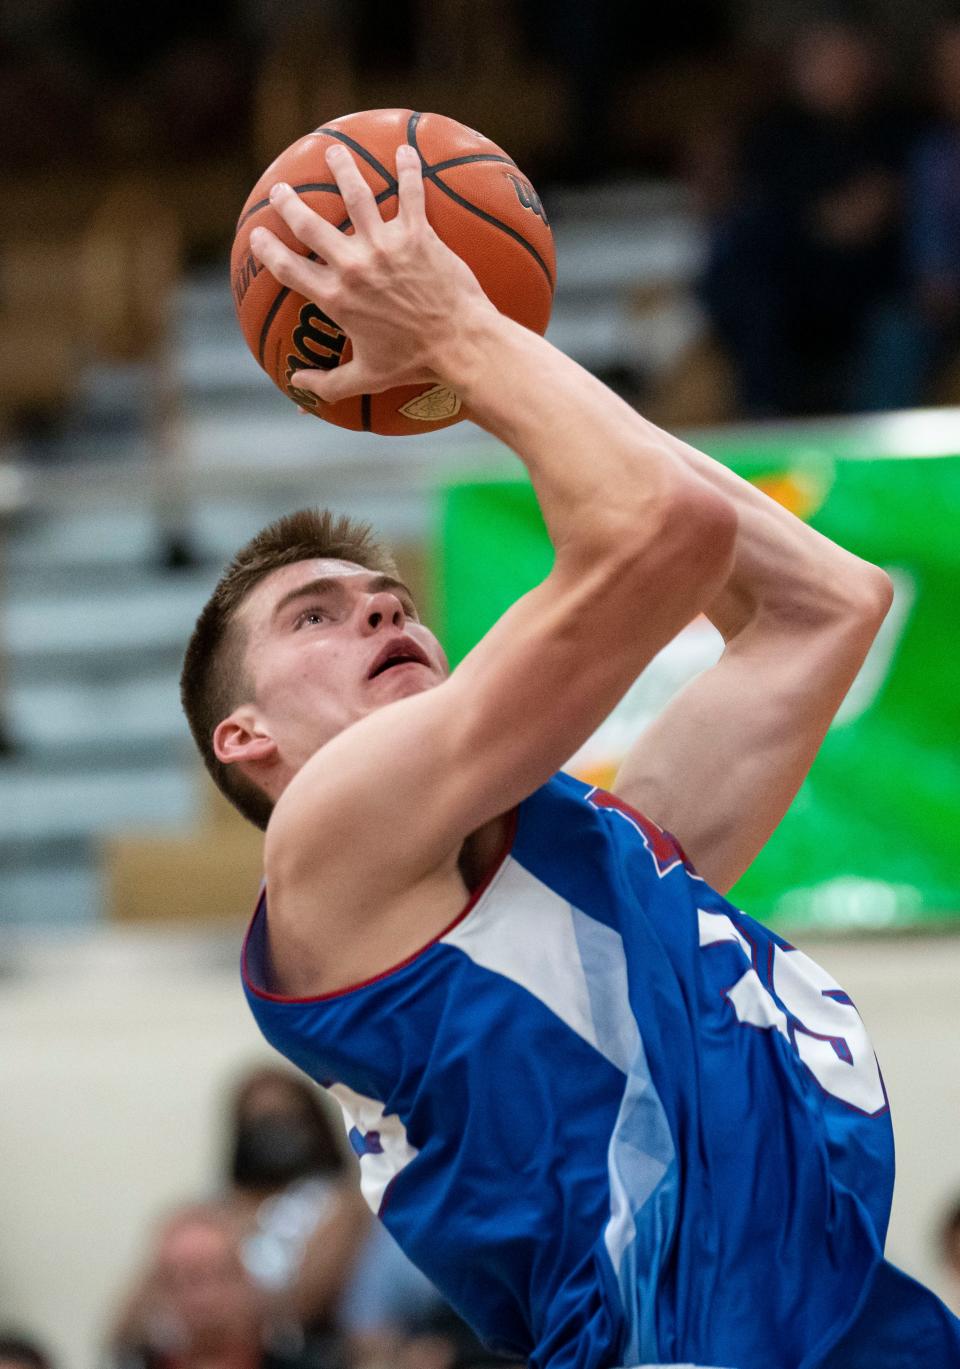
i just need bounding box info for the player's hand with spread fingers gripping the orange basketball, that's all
[251,144,493,402]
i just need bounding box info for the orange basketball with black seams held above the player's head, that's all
[230,110,556,437]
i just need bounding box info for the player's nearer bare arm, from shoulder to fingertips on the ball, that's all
[257,147,735,916]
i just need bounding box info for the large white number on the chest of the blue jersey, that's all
[698,909,887,1117]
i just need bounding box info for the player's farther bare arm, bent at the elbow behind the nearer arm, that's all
[615,424,892,890]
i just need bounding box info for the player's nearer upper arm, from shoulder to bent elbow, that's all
[266,476,735,919]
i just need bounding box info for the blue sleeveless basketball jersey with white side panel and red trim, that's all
[244,775,960,1369]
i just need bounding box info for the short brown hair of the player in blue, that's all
[179,509,397,830]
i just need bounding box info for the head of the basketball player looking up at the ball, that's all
[181,509,446,828]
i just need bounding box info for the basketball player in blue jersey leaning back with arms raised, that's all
[184,146,960,1369]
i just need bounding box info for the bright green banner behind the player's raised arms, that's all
[438,443,960,928]
